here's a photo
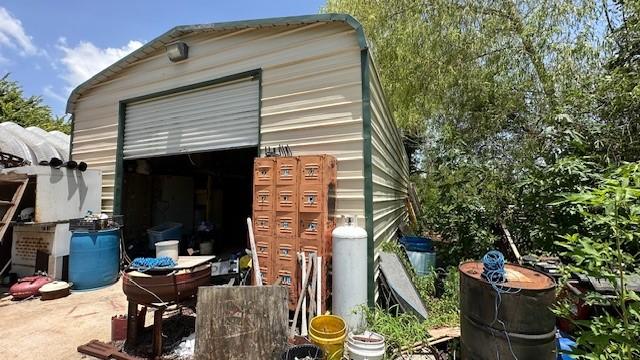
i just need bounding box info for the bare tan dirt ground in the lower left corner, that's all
[0,281,127,359]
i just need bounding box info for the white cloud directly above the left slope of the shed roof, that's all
[57,38,143,91]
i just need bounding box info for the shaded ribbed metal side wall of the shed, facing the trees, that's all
[369,57,409,254]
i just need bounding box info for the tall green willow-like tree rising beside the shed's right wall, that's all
[324,0,609,259]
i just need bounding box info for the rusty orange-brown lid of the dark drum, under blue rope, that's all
[458,261,556,291]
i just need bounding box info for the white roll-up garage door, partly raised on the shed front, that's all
[123,78,260,159]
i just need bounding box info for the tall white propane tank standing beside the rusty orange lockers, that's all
[332,216,367,331]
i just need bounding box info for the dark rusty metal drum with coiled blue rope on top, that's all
[458,262,557,360]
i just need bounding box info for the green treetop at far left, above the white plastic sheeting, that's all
[0,74,71,134]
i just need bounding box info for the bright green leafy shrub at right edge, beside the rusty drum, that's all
[556,163,640,360]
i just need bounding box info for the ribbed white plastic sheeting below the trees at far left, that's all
[0,121,69,164]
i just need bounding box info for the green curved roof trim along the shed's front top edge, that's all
[66,14,368,114]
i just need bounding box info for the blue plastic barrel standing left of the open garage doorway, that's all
[69,229,120,290]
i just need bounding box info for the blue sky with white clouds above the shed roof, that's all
[0,0,324,115]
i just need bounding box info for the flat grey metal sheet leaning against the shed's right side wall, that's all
[380,252,427,320]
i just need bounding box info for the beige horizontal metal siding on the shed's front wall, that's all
[73,23,364,216]
